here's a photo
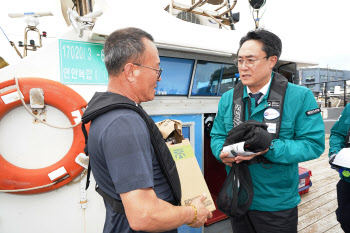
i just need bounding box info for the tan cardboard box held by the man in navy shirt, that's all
[168,139,216,211]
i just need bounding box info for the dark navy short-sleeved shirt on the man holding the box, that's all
[88,109,177,233]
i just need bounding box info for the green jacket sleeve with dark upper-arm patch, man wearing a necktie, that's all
[264,91,325,164]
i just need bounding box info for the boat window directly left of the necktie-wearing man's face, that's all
[191,61,239,96]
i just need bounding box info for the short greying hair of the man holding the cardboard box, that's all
[104,27,154,75]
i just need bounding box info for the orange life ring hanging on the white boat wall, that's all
[0,78,87,194]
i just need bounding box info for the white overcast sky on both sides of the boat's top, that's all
[0,0,350,70]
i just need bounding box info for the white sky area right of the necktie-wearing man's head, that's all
[253,0,350,70]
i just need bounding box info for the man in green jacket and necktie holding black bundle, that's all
[211,29,325,233]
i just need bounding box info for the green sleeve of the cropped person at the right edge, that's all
[329,104,350,156]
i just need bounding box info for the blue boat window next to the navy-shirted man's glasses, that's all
[156,57,194,96]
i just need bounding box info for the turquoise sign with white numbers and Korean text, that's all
[59,40,108,85]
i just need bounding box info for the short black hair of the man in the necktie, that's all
[237,29,282,59]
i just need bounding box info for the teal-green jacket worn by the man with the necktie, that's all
[210,75,325,211]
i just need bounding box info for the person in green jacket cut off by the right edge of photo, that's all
[329,104,350,232]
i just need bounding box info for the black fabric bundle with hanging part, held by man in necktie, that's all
[216,120,272,217]
